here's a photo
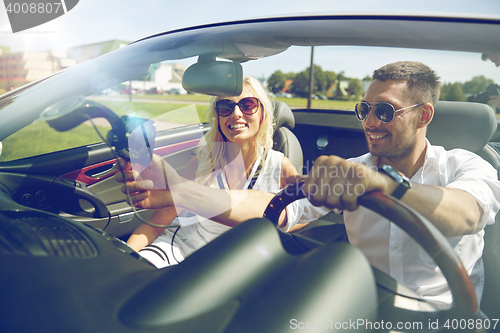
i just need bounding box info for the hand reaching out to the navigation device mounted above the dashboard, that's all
[115,155,184,209]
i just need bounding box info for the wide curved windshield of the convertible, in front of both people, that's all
[0,16,500,162]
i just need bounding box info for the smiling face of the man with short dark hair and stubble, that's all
[362,80,418,162]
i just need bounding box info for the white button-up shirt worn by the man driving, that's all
[299,141,500,308]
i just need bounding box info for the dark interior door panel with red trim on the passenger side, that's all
[0,124,208,237]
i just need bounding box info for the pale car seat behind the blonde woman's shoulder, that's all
[273,101,303,174]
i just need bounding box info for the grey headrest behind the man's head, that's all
[427,101,497,153]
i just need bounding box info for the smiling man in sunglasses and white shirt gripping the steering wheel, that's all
[303,62,500,308]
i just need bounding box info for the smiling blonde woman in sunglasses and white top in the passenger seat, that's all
[127,77,298,268]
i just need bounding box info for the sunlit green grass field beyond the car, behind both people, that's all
[0,94,356,162]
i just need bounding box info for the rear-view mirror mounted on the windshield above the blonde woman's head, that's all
[182,57,243,96]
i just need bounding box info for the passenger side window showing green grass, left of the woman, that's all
[0,82,209,162]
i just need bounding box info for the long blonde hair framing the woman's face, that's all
[196,76,275,185]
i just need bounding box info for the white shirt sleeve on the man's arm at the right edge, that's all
[446,149,500,232]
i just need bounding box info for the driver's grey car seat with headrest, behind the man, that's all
[427,101,500,318]
